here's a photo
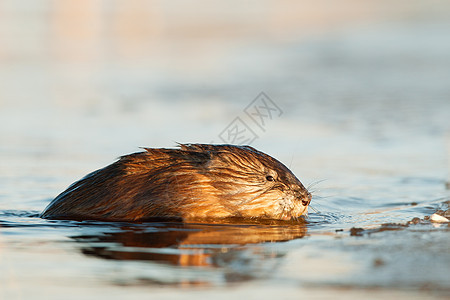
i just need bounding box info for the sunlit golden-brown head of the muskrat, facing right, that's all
[181,144,311,220]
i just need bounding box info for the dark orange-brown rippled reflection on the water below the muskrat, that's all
[72,223,307,285]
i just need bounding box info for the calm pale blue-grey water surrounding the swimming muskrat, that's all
[0,1,450,299]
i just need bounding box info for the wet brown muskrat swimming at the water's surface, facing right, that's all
[40,144,311,221]
